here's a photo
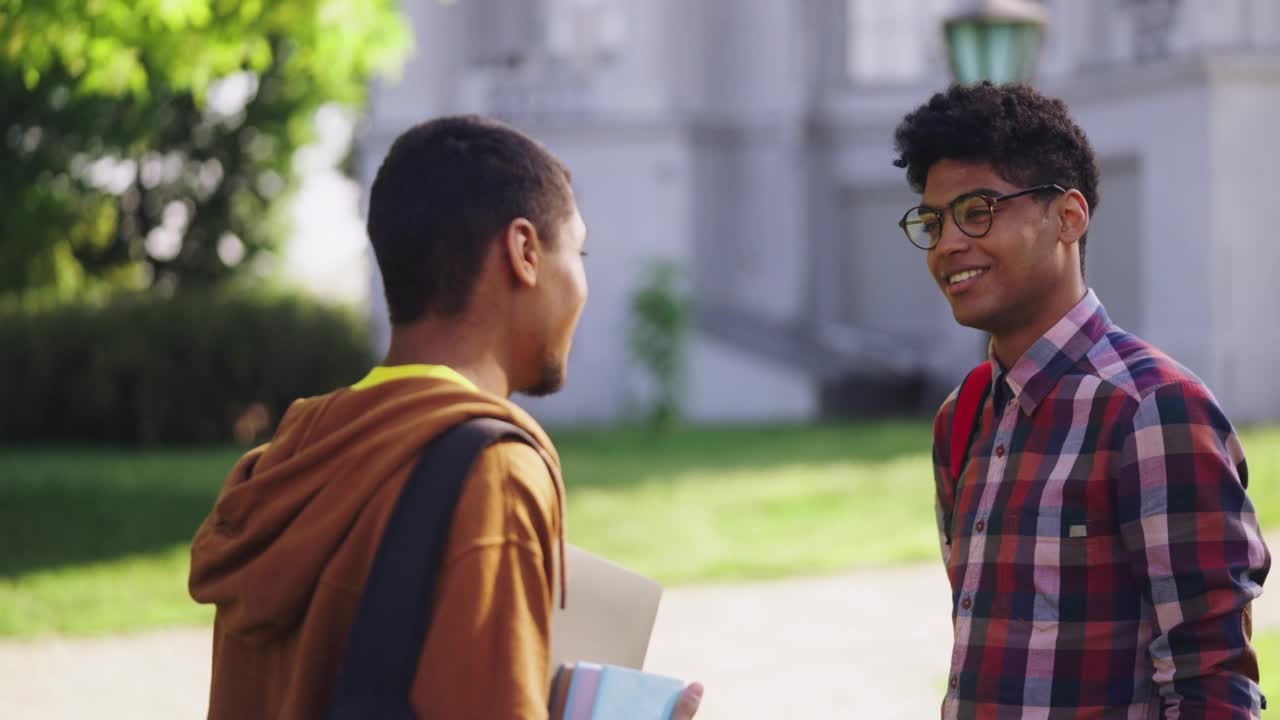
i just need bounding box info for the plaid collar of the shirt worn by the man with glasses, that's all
[988,290,1111,415]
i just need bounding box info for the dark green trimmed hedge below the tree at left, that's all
[0,295,371,445]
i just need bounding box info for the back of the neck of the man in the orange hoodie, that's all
[383,319,512,397]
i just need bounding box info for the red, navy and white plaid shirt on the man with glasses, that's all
[933,291,1271,720]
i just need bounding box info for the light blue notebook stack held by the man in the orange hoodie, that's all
[550,662,685,720]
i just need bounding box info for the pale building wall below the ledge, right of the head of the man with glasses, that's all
[1061,55,1280,424]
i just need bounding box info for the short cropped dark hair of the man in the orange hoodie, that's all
[369,115,572,325]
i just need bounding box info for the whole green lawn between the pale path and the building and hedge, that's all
[0,421,1280,638]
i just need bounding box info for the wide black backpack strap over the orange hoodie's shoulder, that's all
[324,418,539,720]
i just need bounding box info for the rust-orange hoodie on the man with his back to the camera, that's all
[191,366,563,720]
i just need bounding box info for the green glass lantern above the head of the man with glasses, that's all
[942,0,1048,85]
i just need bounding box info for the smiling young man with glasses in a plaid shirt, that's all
[895,83,1270,719]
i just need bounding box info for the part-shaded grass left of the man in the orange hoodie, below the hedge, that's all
[0,448,238,635]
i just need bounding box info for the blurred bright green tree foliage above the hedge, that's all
[0,0,410,297]
